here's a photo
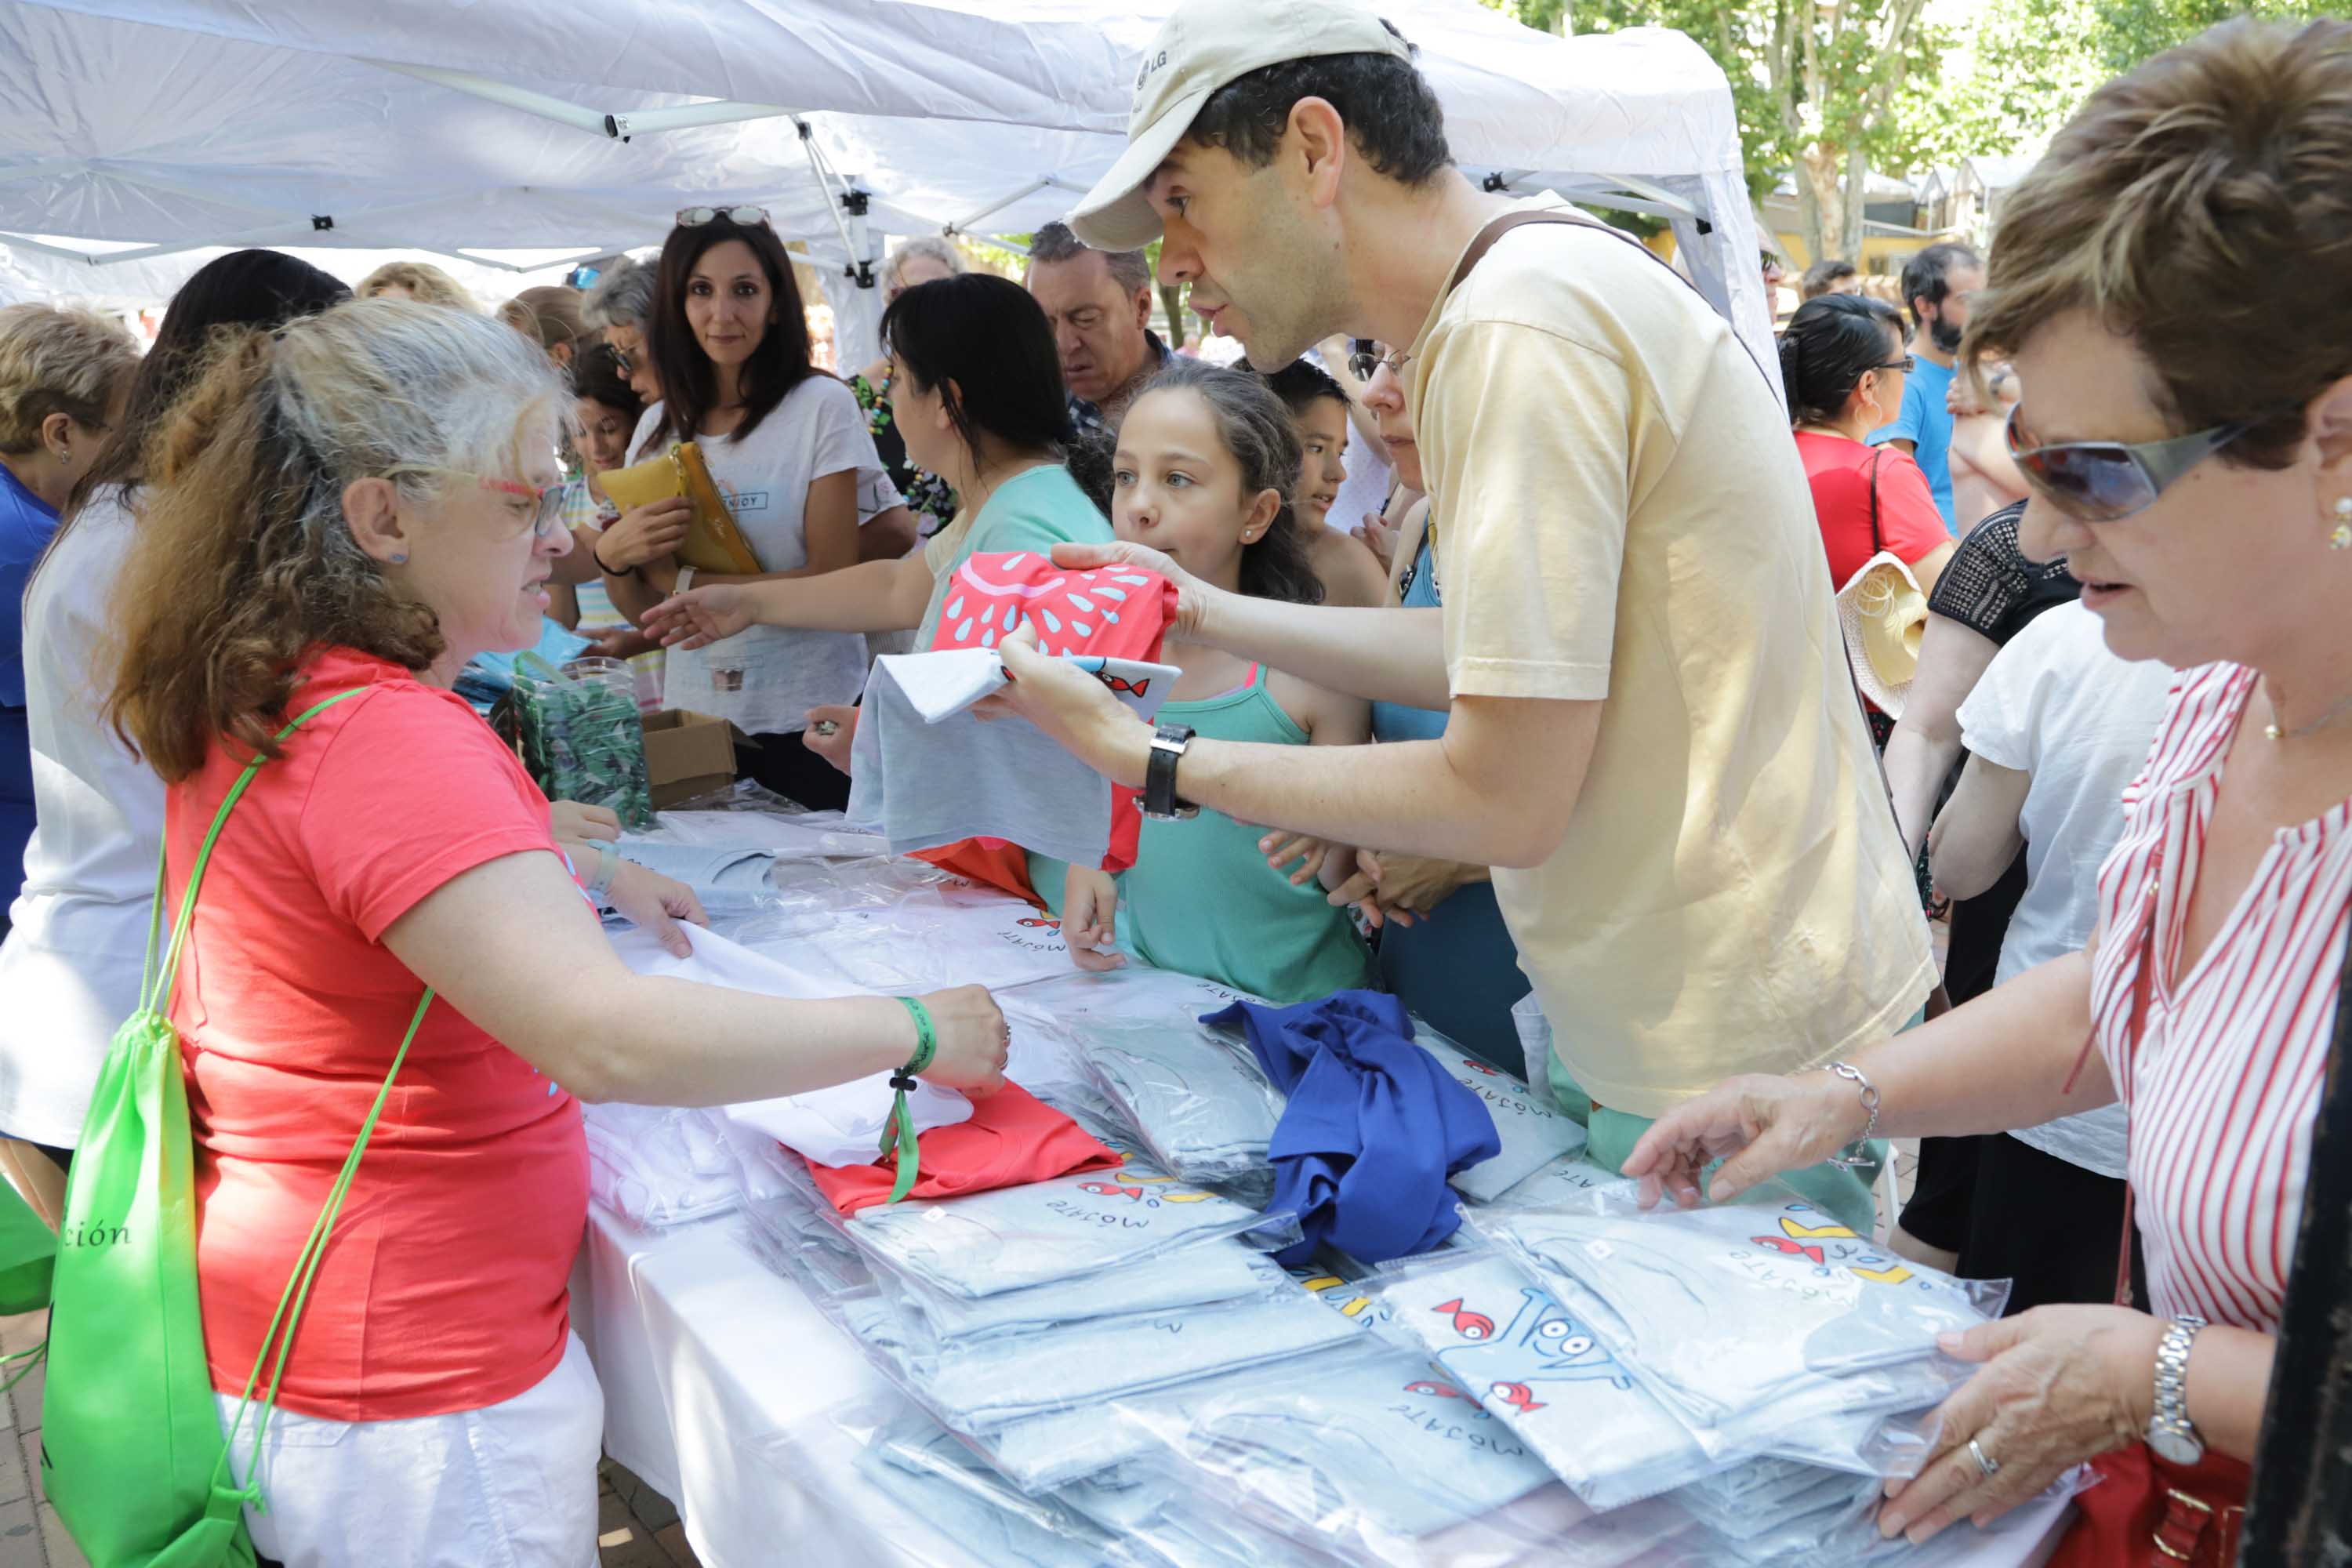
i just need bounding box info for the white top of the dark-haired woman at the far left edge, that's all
[0,489,162,1147]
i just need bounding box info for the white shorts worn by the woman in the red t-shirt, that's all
[214,1335,604,1568]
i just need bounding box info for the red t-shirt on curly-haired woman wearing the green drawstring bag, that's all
[165,649,588,1420]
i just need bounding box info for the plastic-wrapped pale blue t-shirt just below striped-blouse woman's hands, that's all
[1472,1182,2009,1457]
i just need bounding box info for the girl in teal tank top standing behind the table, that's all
[1061,360,1371,1001]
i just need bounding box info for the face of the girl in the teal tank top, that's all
[1110,388,1282,588]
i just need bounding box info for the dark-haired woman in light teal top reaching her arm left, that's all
[644,273,1110,760]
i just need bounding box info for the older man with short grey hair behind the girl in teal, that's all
[1023,223,1169,435]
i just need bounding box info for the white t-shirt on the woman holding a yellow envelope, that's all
[630,385,898,736]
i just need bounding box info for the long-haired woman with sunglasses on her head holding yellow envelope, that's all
[593,207,898,811]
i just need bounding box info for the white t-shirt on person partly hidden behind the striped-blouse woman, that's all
[1959,604,2173,1178]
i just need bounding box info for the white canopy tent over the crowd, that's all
[0,0,1771,373]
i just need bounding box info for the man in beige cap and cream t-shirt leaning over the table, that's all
[1002,0,1936,1234]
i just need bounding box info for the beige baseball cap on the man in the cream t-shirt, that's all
[1070,0,1414,252]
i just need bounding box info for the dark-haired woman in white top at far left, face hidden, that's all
[0,252,350,1163]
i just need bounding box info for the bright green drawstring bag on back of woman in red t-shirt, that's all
[40,691,433,1568]
